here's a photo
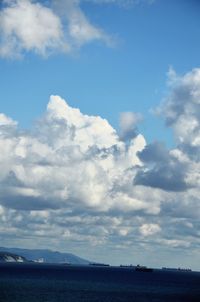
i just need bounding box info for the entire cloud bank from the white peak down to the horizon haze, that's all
[0,69,200,265]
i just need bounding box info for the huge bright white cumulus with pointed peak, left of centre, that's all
[0,96,150,211]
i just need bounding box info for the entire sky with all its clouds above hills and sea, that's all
[0,0,200,270]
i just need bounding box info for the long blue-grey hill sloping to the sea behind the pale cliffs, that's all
[0,247,90,264]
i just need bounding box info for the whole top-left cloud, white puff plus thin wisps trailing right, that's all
[0,0,111,58]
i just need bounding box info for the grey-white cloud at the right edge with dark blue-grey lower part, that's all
[135,68,200,196]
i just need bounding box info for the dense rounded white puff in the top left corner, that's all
[0,0,65,57]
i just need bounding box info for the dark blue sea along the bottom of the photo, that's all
[0,263,200,302]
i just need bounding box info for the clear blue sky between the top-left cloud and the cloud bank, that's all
[0,0,200,144]
